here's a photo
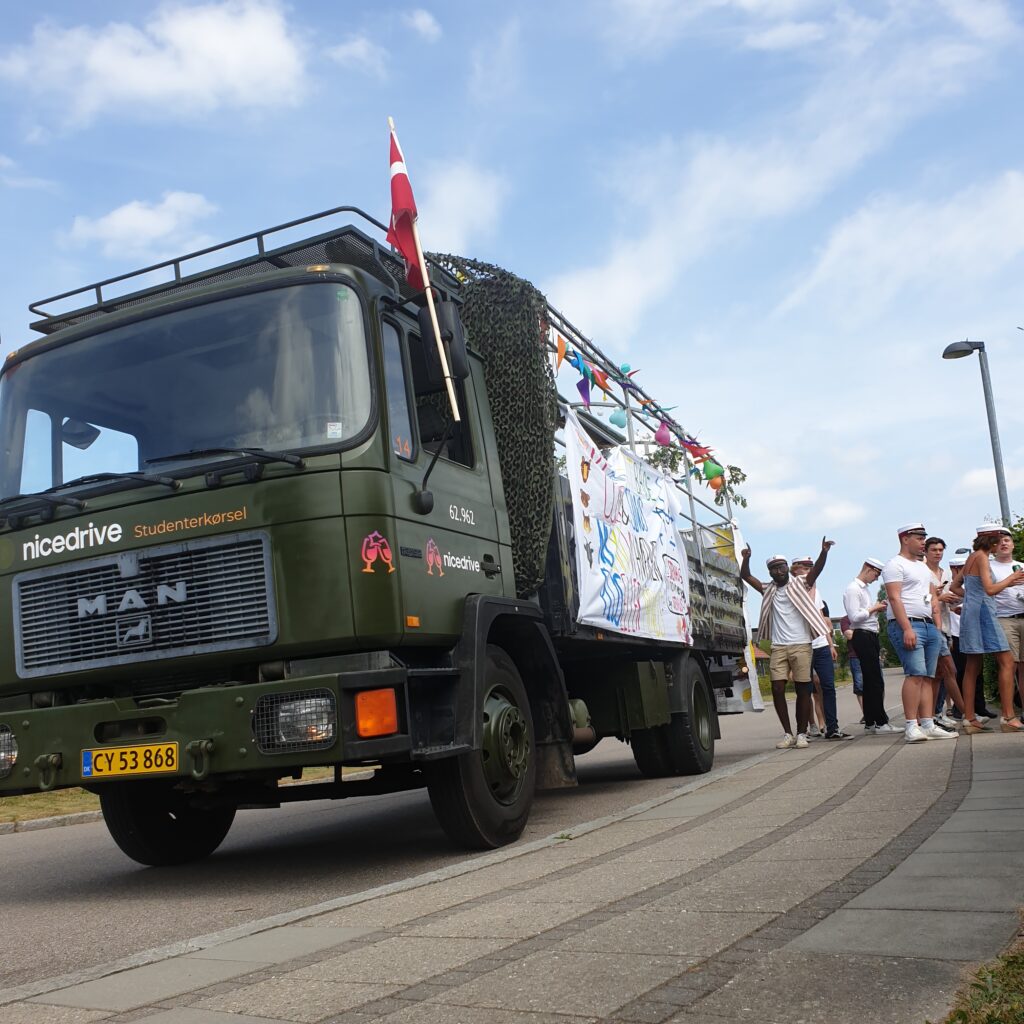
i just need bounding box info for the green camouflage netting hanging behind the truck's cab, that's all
[431,253,558,597]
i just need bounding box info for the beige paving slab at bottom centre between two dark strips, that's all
[431,947,683,1017]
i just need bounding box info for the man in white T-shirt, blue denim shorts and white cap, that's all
[882,522,957,743]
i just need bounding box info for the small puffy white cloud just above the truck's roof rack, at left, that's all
[66,191,217,257]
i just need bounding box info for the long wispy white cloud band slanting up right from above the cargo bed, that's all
[545,8,1011,343]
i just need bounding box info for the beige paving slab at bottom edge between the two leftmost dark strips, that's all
[192,973,402,1024]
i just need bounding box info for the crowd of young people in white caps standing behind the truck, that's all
[739,522,1024,750]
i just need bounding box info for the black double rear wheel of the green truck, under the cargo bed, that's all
[630,658,715,778]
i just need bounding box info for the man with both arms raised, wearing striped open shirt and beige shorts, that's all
[739,544,830,751]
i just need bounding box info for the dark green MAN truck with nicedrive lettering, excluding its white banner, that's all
[0,207,746,864]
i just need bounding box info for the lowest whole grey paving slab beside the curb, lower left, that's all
[31,956,259,1011]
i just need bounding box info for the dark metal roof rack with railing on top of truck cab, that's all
[29,206,459,335]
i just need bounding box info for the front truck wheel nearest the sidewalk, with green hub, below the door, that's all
[427,647,537,850]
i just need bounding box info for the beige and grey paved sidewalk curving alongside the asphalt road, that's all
[0,734,1024,1024]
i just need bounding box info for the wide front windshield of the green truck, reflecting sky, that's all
[0,282,371,498]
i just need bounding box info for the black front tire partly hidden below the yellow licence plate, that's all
[99,783,236,867]
